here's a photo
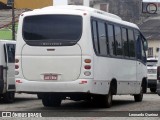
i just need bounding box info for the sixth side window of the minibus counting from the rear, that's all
[128,29,135,57]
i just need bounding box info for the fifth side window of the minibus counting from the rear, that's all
[122,28,129,57]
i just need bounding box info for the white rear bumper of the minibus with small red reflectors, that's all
[16,78,109,94]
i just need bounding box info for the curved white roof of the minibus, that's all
[22,5,139,29]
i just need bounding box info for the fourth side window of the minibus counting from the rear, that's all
[115,26,123,56]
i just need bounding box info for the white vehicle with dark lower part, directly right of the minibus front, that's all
[147,57,158,92]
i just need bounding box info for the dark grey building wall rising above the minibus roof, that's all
[92,0,142,24]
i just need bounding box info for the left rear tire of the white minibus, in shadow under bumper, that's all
[42,94,62,107]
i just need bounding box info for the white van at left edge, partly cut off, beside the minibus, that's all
[0,40,16,103]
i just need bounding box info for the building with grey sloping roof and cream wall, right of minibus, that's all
[139,16,160,57]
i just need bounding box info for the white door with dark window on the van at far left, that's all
[5,43,15,91]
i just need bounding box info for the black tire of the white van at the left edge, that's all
[3,92,15,103]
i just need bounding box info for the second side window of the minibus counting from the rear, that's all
[98,22,107,55]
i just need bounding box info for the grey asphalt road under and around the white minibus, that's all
[0,89,160,120]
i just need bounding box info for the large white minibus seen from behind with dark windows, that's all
[15,5,147,107]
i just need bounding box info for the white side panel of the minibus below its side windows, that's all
[94,56,137,94]
